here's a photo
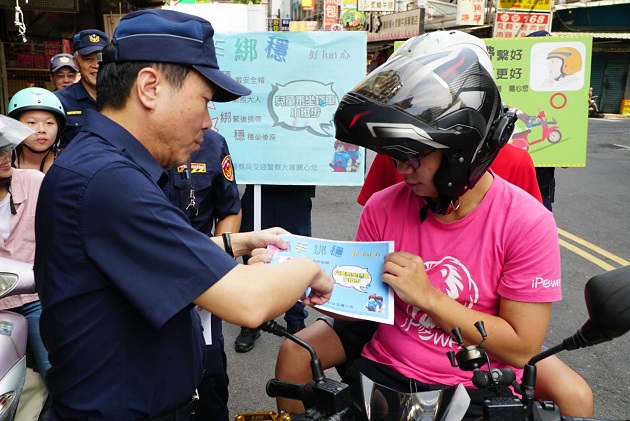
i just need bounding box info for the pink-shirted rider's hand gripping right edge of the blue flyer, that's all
[383,251,441,309]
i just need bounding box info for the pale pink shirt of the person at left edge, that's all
[0,168,44,310]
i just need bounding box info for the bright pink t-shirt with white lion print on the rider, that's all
[356,175,562,387]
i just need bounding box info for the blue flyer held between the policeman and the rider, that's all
[269,235,394,324]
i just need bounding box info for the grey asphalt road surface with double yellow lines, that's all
[224,119,630,419]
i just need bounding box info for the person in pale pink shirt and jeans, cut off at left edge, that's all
[0,115,50,419]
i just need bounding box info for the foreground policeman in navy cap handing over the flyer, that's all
[34,9,333,421]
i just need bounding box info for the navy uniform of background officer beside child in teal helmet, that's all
[54,81,96,149]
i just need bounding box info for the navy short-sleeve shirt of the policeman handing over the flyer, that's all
[35,111,241,420]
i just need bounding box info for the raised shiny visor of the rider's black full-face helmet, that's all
[353,48,481,124]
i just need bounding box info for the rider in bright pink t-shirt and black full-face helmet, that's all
[276,48,561,419]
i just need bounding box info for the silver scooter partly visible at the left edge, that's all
[0,257,35,421]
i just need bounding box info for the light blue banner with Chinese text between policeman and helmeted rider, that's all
[208,31,367,186]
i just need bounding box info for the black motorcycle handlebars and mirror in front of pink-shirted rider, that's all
[236,266,630,421]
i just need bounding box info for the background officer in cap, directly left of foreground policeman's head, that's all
[55,29,109,149]
